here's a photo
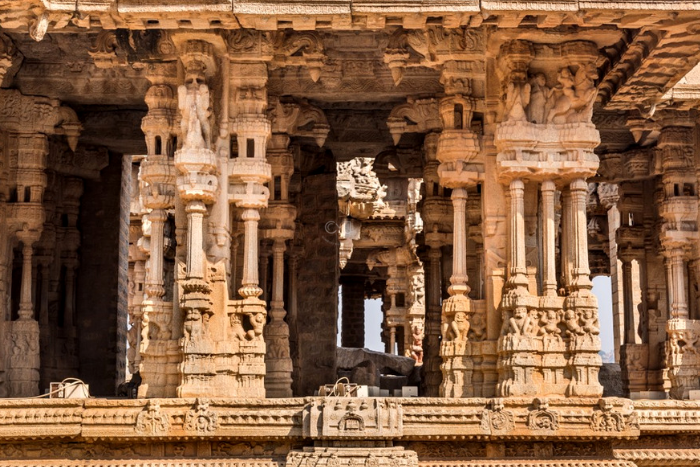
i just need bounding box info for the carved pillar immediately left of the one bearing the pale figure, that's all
[135,71,176,397]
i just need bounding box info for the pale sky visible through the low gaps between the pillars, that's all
[338,276,614,358]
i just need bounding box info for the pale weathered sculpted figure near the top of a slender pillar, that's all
[177,73,211,149]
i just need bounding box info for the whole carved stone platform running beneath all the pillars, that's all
[0,398,700,467]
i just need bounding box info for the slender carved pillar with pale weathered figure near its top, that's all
[172,40,219,397]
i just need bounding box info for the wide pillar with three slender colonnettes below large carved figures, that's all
[494,40,602,396]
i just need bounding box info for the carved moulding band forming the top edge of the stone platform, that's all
[0,398,700,441]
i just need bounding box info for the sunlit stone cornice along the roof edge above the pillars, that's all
[5,0,700,34]
